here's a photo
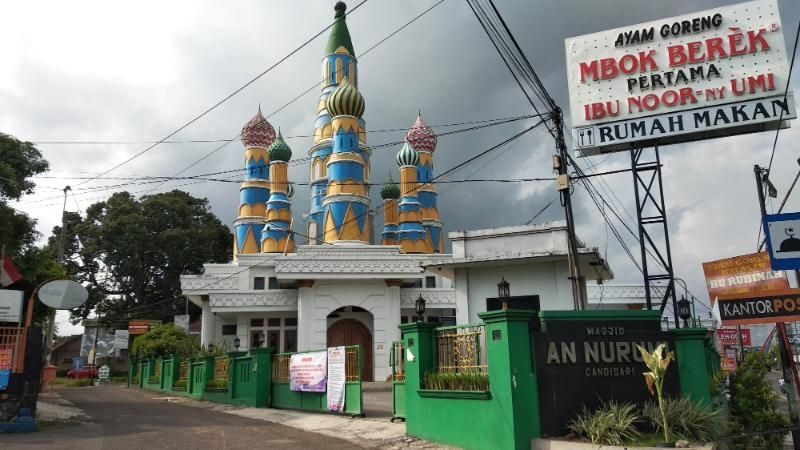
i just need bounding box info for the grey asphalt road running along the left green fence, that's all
[0,386,355,450]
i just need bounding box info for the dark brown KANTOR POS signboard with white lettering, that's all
[714,289,800,326]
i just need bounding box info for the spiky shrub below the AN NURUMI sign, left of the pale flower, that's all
[569,401,640,445]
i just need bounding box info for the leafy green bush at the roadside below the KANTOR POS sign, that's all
[727,352,790,448]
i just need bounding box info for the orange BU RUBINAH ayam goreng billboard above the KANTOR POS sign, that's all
[703,252,789,304]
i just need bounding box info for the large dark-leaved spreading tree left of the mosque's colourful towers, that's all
[59,190,233,323]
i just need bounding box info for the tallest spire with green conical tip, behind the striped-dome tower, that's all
[307,2,369,244]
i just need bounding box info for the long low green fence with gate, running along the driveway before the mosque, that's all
[128,345,364,417]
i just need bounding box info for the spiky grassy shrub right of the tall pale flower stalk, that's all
[642,397,720,442]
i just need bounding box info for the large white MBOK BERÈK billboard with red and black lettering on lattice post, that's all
[565,0,797,155]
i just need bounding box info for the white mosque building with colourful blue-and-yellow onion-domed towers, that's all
[181,2,610,381]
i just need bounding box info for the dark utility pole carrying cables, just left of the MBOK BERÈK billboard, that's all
[552,106,586,311]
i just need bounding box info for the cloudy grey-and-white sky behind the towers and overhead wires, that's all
[6,0,800,332]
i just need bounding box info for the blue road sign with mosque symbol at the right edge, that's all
[764,213,800,270]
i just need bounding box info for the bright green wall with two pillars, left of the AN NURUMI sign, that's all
[400,310,539,449]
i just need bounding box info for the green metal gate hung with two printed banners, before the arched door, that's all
[270,345,364,417]
